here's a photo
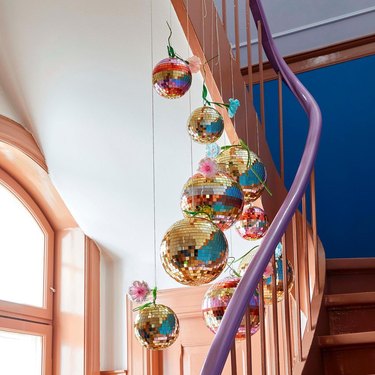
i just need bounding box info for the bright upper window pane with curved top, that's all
[0,183,44,308]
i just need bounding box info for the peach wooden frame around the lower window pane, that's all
[0,317,52,375]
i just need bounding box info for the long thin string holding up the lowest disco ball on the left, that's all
[150,0,157,287]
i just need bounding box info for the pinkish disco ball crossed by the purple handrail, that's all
[202,277,259,339]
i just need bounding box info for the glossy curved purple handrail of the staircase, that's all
[201,0,322,375]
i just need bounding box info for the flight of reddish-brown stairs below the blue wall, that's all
[319,258,375,375]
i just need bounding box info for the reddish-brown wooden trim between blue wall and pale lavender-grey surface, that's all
[241,34,375,84]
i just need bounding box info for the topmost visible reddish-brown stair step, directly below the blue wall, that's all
[327,258,375,294]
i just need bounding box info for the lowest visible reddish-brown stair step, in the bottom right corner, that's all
[319,331,375,375]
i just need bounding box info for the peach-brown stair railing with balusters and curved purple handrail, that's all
[171,0,325,375]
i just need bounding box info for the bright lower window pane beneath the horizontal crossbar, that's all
[0,331,43,375]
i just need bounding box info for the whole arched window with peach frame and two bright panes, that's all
[0,171,54,375]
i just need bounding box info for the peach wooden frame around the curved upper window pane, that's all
[0,170,54,323]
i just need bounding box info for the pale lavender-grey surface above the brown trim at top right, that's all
[215,0,375,66]
